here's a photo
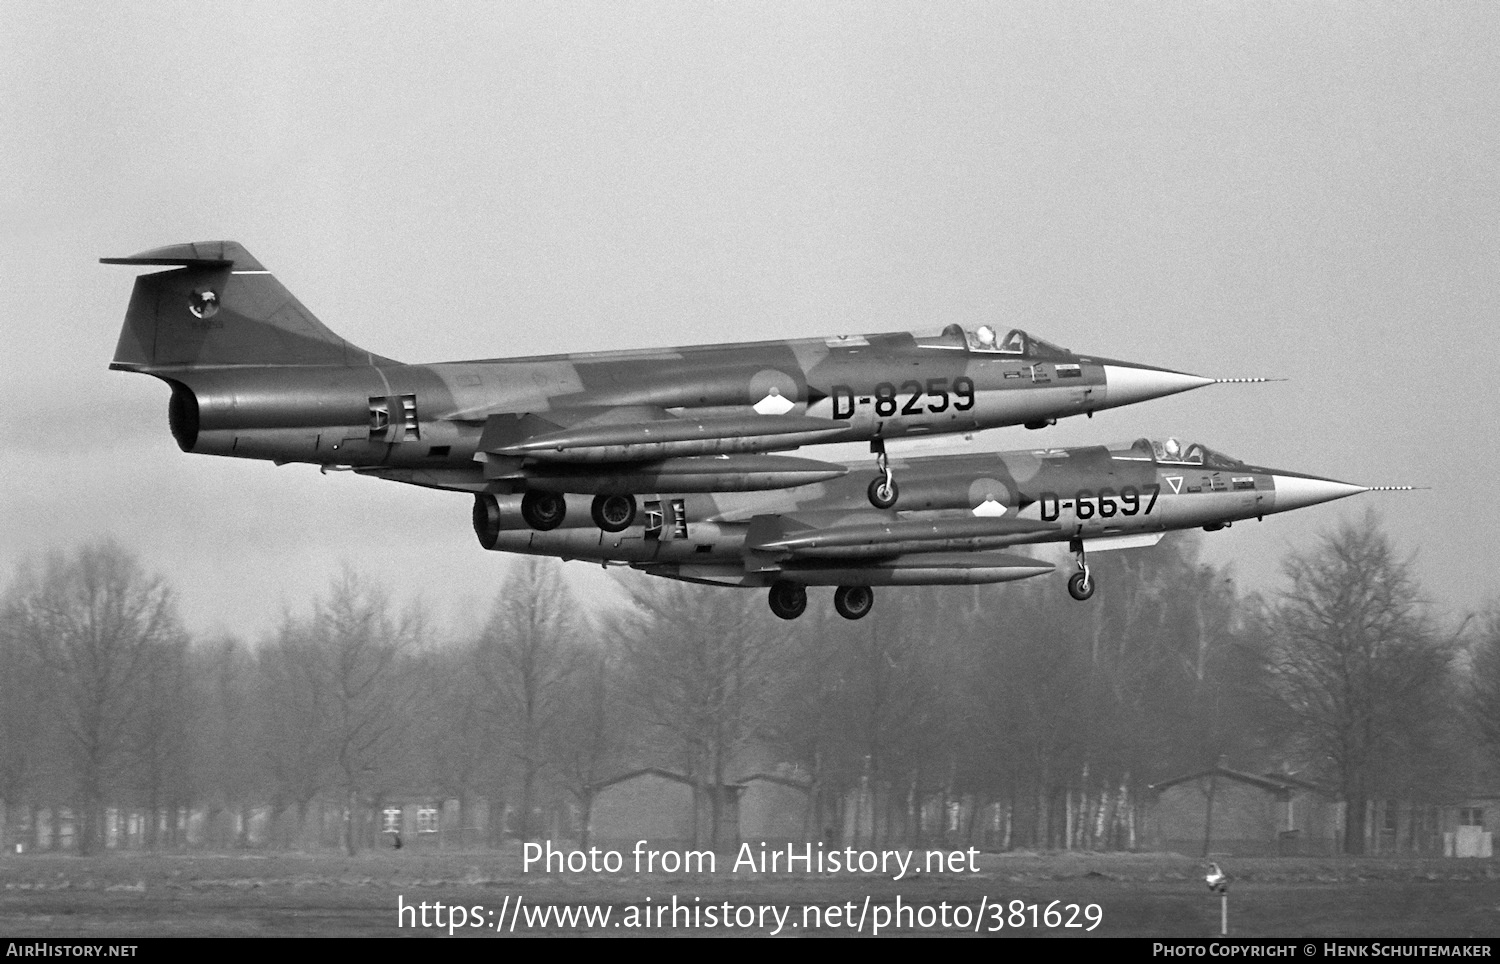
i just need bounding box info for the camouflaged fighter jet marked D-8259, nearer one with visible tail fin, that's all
[102,241,1242,532]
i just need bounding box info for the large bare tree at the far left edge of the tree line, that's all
[8,541,183,853]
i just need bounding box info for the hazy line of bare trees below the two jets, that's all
[0,514,1500,853]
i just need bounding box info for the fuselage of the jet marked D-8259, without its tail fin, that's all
[153,334,1208,492]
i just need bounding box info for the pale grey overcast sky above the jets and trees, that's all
[0,0,1500,636]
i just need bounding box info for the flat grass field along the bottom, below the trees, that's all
[0,849,1500,937]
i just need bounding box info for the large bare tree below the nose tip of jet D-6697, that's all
[1259,513,1452,853]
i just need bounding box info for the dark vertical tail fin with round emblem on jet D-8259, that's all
[101,241,392,372]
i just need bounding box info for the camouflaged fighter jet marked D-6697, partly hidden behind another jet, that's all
[474,438,1394,619]
